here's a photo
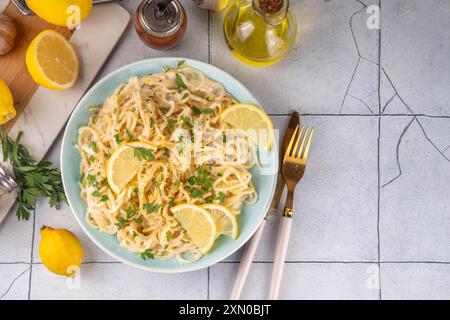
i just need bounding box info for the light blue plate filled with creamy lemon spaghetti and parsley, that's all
[61,58,278,272]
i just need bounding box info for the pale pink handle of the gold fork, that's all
[269,216,292,300]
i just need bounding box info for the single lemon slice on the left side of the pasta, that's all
[106,141,156,193]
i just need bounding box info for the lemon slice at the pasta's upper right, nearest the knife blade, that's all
[219,103,274,149]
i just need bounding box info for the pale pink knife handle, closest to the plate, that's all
[230,219,266,300]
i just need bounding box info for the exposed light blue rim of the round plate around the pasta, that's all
[61,58,278,273]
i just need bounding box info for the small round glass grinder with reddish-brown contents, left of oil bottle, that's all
[134,0,187,49]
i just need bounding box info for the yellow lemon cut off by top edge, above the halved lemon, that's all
[26,0,92,29]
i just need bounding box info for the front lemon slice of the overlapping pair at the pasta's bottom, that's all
[171,204,217,254]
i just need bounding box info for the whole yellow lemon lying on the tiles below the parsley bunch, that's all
[39,226,83,277]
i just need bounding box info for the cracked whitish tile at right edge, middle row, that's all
[380,117,450,261]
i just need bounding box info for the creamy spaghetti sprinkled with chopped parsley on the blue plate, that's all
[76,65,257,262]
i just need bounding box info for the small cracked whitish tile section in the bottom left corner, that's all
[0,263,30,300]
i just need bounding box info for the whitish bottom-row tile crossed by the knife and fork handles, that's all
[210,263,378,300]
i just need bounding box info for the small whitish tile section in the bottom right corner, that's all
[380,263,450,300]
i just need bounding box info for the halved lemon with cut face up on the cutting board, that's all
[25,30,78,90]
